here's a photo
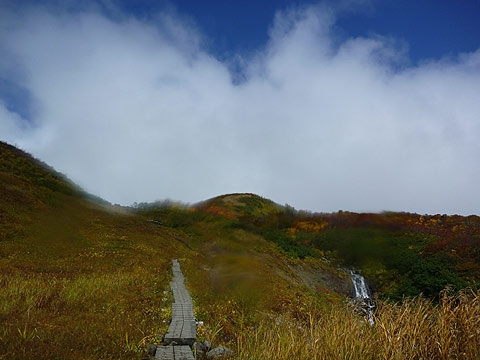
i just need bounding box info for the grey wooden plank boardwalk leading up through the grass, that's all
[155,260,197,360]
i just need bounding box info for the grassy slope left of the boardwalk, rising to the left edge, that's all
[0,143,189,359]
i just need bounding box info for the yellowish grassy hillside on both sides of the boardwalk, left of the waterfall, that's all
[0,143,346,359]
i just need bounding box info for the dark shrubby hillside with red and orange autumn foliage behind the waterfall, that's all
[192,194,480,300]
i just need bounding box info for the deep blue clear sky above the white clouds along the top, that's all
[109,0,480,63]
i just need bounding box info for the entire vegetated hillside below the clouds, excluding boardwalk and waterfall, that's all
[0,143,480,359]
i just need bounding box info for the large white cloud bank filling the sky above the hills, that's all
[0,3,480,214]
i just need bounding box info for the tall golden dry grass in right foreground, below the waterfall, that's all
[236,290,480,360]
